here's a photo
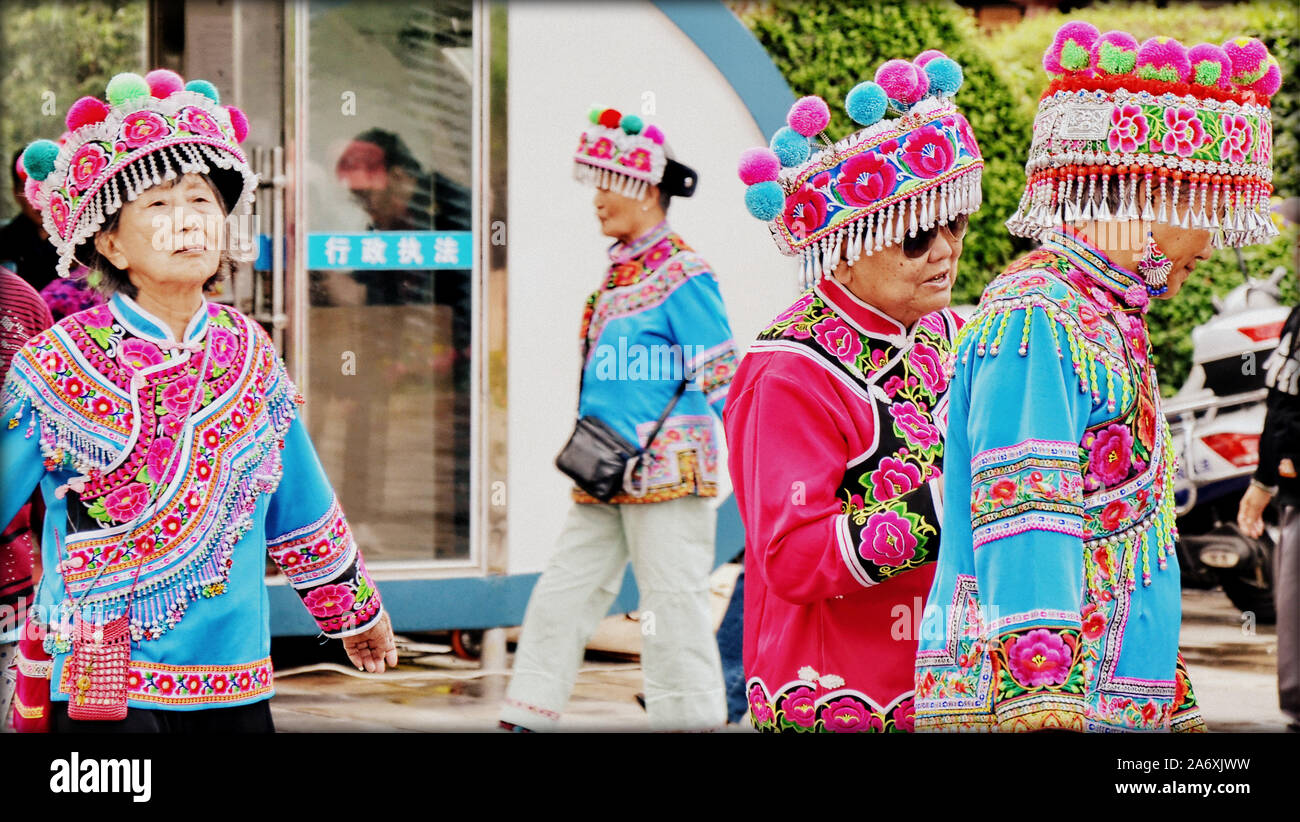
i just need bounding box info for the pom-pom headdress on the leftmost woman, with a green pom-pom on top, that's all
[21,69,257,277]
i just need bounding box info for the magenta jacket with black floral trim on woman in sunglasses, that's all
[725,278,959,731]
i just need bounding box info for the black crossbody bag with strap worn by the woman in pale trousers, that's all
[555,339,692,502]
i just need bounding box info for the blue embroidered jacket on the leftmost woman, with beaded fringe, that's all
[0,294,381,710]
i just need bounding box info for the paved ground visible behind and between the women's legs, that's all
[272,577,1284,732]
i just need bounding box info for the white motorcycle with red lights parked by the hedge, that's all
[1164,252,1290,624]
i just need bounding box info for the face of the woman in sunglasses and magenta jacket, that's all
[835,216,967,326]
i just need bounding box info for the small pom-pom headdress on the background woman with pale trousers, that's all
[573,107,699,199]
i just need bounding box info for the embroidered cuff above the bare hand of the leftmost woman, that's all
[267,498,382,637]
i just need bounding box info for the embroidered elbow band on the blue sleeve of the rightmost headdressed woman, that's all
[971,440,1084,549]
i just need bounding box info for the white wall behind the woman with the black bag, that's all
[508,1,797,574]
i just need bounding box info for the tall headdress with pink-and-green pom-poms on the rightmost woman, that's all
[1006,21,1282,246]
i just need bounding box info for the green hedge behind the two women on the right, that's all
[736,0,1300,394]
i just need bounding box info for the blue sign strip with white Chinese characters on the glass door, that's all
[307,232,475,271]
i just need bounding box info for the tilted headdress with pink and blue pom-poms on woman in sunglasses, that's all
[740,49,984,286]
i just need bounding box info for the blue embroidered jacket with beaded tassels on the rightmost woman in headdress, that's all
[917,233,1204,731]
